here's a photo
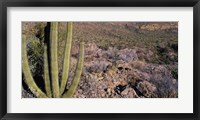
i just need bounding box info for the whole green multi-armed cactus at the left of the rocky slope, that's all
[22,22,84,98]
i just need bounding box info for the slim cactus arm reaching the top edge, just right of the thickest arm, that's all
[60,22,72,95]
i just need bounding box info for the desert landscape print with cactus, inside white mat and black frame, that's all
[22,22,178,98]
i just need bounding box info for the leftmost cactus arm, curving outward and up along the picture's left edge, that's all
[22,35,47,98]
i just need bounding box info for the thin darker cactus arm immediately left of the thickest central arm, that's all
[44,43,52,98]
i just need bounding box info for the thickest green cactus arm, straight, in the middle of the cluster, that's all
[50,22,60,98]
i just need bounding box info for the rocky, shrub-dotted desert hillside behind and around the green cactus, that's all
[23,22,178,98]
